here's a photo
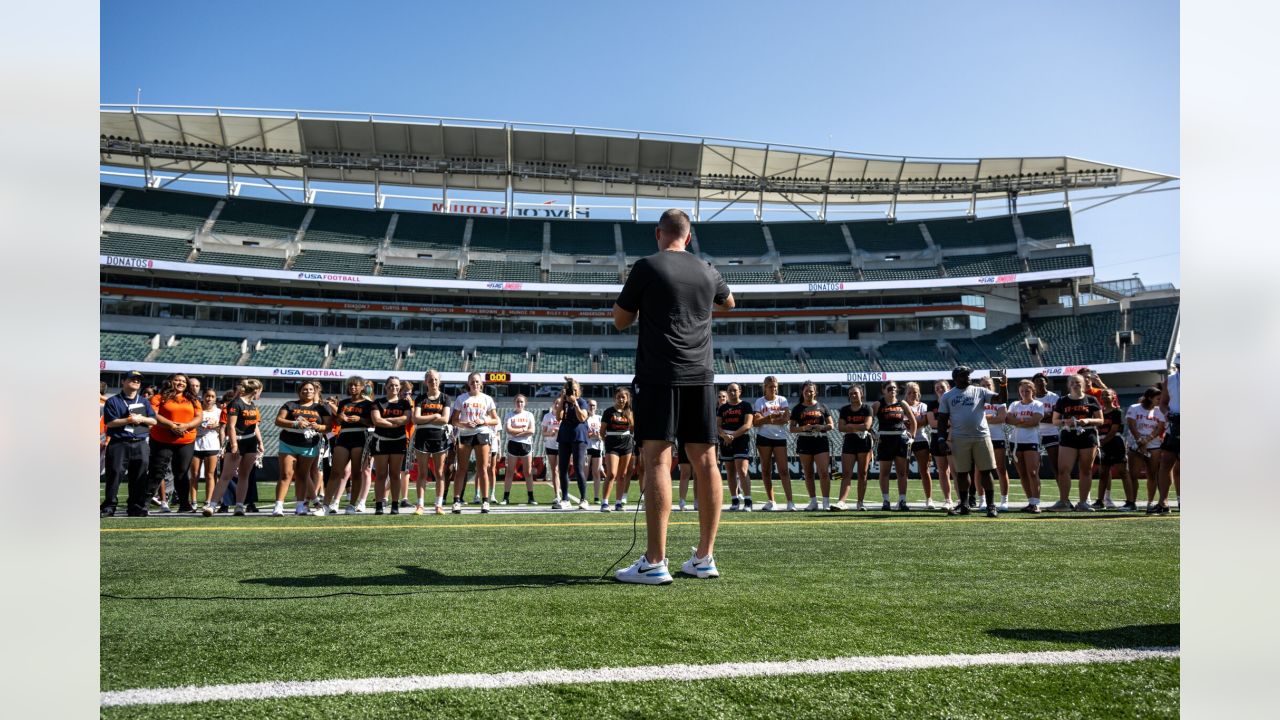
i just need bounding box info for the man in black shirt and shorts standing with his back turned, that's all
[613,209,735,585]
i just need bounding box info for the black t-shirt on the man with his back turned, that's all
[617,251,728,386]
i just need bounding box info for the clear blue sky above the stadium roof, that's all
[100,0,1180,284]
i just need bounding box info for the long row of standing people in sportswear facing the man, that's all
[100,369,1180,516]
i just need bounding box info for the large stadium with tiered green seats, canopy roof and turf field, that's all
[99,105,1179,717]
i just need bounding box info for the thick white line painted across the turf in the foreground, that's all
[102,647,1179,707]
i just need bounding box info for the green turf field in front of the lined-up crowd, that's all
[101,502,1179,717]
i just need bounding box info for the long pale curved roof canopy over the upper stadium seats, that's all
[100,105,1178,214]
